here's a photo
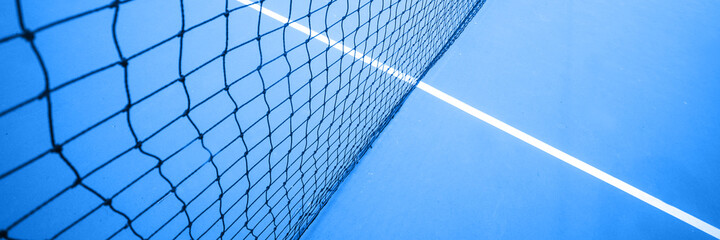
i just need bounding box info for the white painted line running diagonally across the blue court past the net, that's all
[237,0,720,239]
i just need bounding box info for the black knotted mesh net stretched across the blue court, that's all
[0,0,484,239]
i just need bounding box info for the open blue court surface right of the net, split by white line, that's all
[303,0,720,239]
